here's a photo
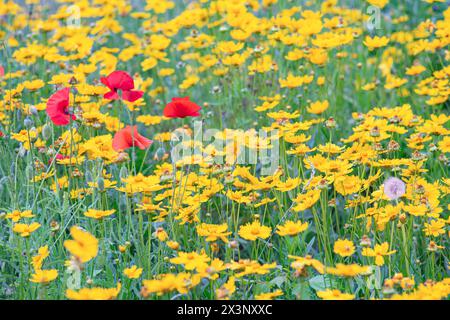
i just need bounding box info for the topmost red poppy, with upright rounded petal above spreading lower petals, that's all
[100,70,144,102]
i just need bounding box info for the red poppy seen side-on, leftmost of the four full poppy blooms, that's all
[46,88,76,126]
